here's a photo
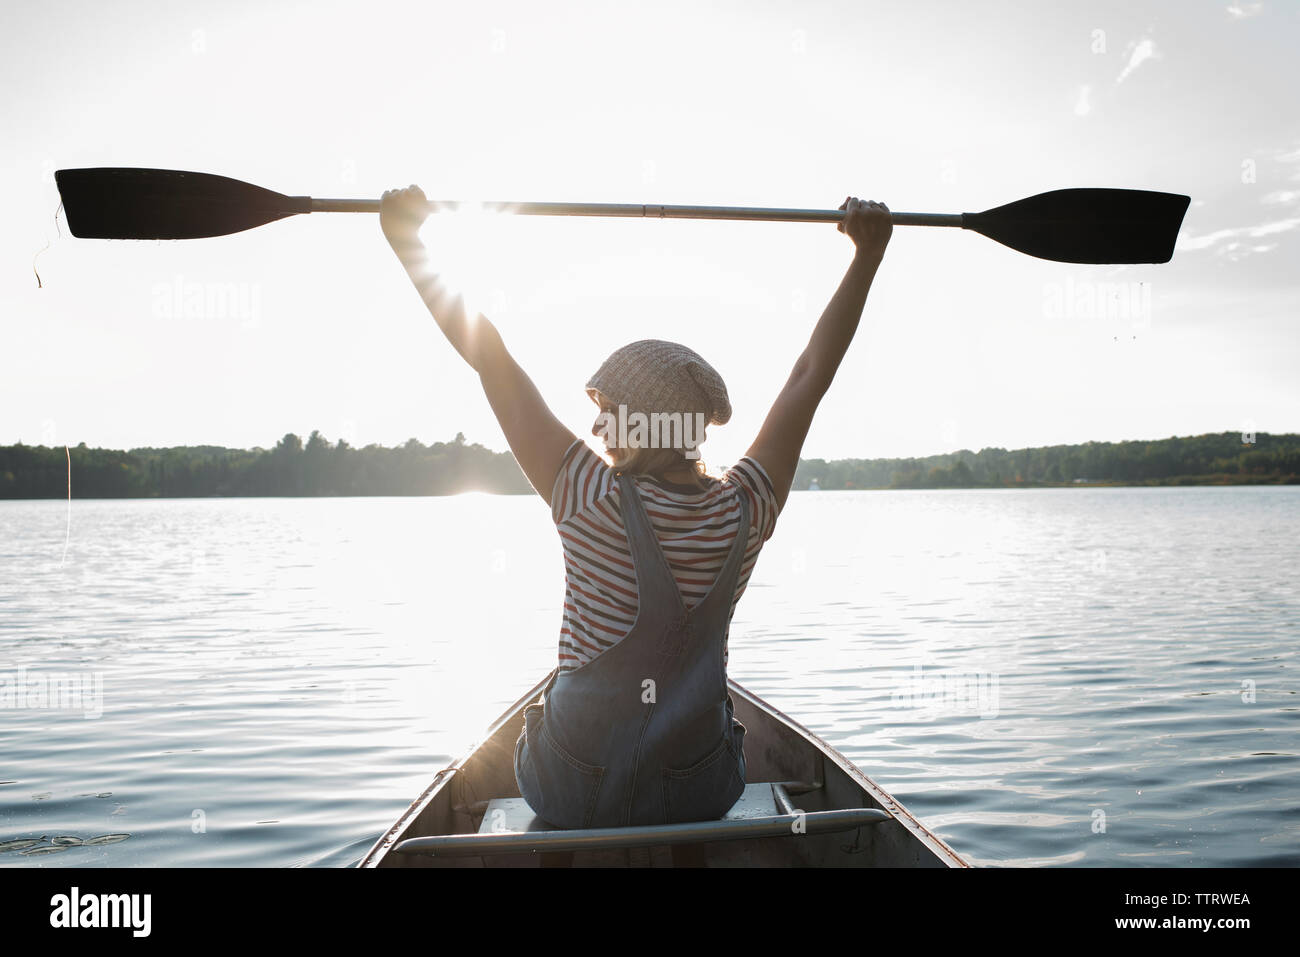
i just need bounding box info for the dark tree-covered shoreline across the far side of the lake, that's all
[0,432,1300,498]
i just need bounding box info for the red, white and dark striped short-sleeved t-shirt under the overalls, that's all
[551,438,779,671]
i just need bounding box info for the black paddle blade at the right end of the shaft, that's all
[962,189,1192,263]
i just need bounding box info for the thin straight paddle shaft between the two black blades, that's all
[311,199,962,228]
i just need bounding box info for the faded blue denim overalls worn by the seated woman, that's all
[515,472,749,828]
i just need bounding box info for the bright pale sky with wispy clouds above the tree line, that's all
[0,0,1300,465]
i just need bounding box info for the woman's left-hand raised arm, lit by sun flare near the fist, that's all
[380,186,577,505]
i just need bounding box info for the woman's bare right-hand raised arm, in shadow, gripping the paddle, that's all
[746,196,893,508]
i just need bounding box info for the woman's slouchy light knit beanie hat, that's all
[586,339,731,425]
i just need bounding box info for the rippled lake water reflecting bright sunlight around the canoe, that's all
[0,488,1300,867]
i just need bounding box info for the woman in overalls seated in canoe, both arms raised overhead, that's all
[380,186,892,827]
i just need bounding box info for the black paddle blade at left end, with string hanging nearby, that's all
[55,166,312,239]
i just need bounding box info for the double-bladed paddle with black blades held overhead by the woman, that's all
[55,166,1191,263]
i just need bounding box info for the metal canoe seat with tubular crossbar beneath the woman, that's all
[394,781,892,857]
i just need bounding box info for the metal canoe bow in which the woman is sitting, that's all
[359,675,970,867]
